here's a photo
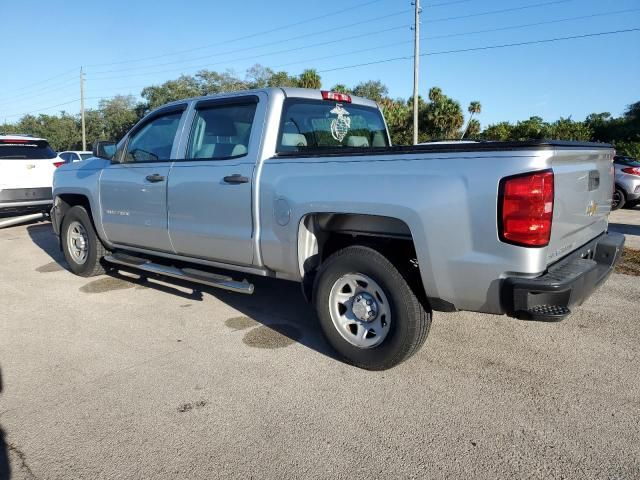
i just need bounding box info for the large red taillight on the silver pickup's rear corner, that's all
[498,170,553,247]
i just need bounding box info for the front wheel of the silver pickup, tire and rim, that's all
[60,205,109,277]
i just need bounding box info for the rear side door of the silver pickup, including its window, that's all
[168,95,265,265]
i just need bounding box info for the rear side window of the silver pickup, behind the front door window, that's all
[187,103,256,160]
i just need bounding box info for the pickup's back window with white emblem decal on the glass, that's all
[278,99,389,152]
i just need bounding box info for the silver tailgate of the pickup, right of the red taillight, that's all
[547,147,614,264]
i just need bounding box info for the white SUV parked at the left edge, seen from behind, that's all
[0,135,64,214]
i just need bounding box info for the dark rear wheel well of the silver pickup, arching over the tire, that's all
[298,213,426,302]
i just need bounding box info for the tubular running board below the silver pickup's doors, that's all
[104,253,253,295]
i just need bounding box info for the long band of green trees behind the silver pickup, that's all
[0,64,640,152]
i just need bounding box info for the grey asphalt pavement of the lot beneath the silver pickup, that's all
[0,223,640,479]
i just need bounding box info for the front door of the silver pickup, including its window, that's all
[100,104,186,252]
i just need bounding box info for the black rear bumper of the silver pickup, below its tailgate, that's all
[502,233,624,321]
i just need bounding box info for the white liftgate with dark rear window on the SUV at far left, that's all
[0,138,58,192]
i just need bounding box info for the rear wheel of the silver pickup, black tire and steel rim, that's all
[313,246,431,370]
